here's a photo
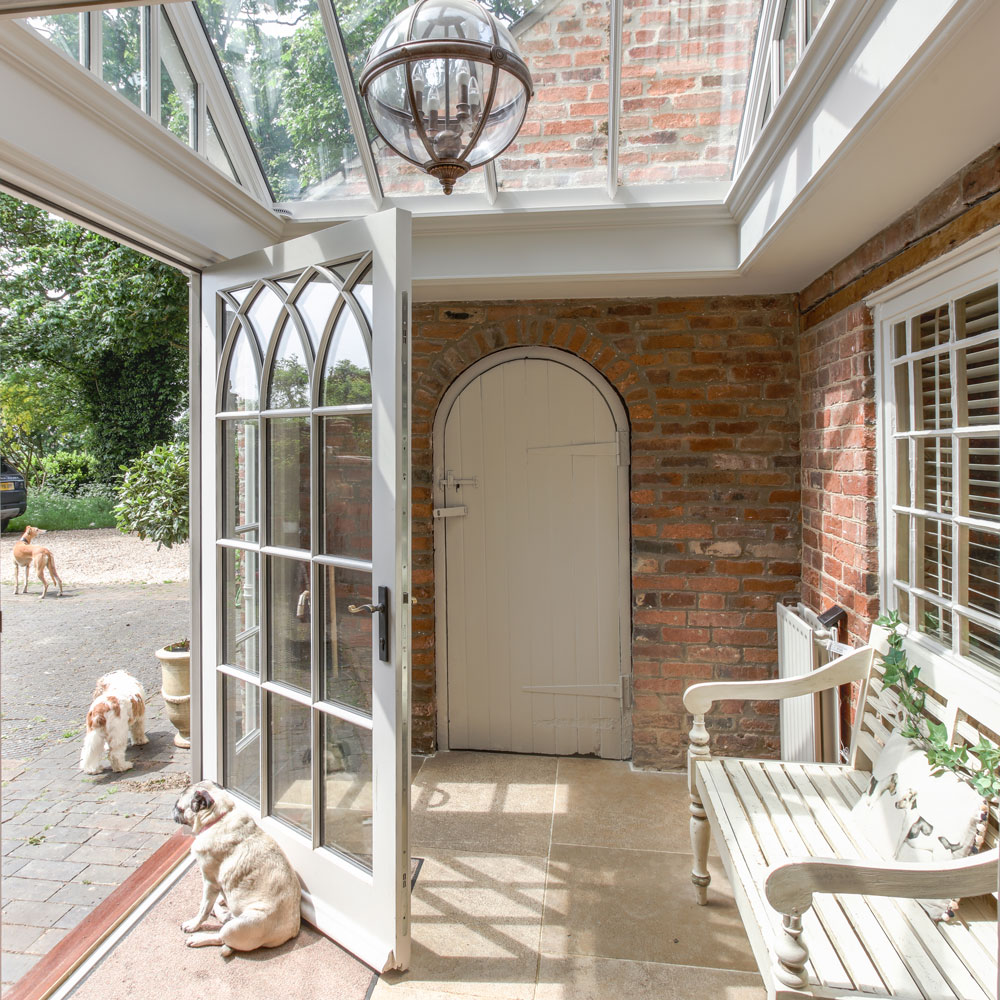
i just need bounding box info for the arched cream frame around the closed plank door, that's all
[432,347,632,760]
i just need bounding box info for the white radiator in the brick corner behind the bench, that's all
[778,604,847,763]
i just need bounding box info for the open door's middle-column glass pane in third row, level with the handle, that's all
[265,556,312,691]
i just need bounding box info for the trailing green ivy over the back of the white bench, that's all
[875,611,1000,799]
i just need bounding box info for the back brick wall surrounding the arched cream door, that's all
[412,296,800,768]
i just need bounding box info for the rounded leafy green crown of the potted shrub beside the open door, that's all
[114,441,190,549]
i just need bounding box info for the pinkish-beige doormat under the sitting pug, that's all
[62,858,422,1000]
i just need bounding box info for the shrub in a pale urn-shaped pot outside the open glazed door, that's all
[115,441,191,747]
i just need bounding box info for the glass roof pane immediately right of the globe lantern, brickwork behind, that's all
[496,0,611,191]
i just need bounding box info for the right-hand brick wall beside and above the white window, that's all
[799,146,1000,641]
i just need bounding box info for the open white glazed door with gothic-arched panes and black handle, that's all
[201,210,410,970]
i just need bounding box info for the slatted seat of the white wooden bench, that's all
[696,758,997,1000]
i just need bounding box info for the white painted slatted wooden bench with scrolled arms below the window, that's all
[684,630,1000,1000]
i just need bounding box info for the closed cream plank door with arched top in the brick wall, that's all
[444,358,628,759]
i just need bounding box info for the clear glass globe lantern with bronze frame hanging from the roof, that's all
[359,0,533,194]
